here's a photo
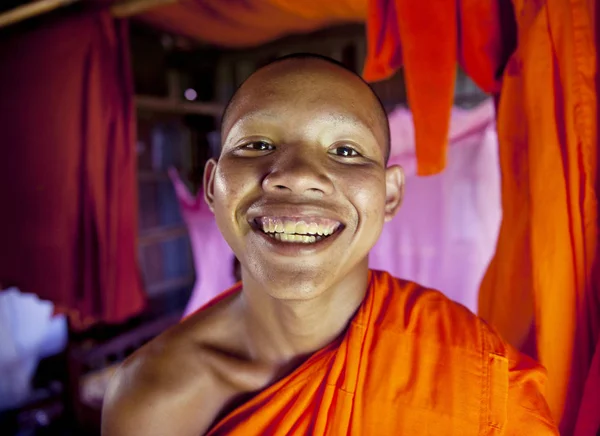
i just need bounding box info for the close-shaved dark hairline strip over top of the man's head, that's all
[221,53,391,163]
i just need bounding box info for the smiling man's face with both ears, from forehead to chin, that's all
[205,61,401,299]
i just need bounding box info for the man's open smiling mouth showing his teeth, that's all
[254,217,342,244]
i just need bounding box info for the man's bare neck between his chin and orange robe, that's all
[242,260,368,367]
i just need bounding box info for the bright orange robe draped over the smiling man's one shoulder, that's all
[209,271,558,436]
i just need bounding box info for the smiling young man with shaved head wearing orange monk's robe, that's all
[103,55,557,436]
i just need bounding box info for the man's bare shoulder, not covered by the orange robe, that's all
[102,290,244,436]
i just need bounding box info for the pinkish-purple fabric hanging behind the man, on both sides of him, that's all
[176,101,501,315]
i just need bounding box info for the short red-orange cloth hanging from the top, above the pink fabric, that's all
[363,0,514,175]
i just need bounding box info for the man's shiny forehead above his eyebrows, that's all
[223,61,381,138]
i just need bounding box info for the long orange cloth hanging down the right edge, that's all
[479,0,600,434]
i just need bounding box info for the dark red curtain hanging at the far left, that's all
[0,13,145,328]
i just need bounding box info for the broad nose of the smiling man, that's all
[262,153,333,197]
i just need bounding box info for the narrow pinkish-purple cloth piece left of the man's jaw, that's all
[169,168,235,317]
